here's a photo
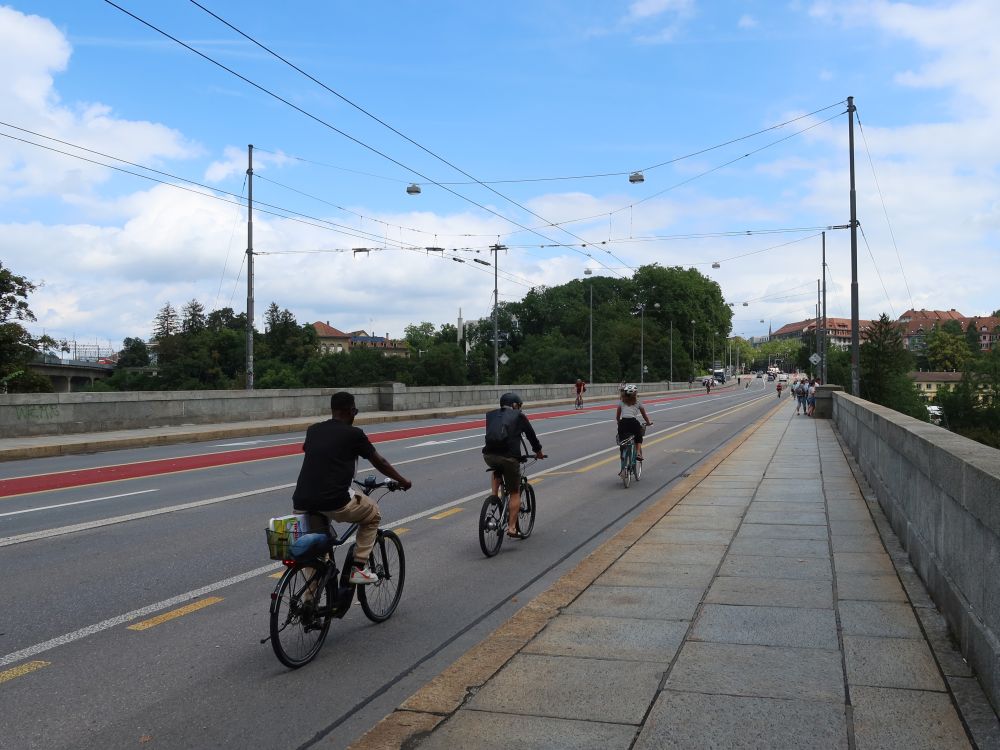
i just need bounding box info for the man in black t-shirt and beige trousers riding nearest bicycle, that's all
[292,391,413,584]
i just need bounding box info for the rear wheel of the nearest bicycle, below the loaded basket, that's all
[270,564,336,669]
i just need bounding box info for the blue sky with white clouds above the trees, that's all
[0,0,1000,345]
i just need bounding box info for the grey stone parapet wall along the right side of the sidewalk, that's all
[833,393,1000,710]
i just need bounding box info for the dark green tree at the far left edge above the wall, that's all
[0,263,58,393]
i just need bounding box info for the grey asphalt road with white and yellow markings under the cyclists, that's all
[0,380,775,750]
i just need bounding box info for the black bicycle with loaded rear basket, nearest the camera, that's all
[261,476,406,669]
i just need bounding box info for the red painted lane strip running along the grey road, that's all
[0,393,704,497]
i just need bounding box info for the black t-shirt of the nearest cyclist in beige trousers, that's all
[292,419,375,510]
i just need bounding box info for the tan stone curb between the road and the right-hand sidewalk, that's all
[349,396,783,750]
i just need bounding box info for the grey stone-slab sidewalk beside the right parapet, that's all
[357,406,1000,750]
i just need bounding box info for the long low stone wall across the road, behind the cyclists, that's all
[0,383,687,437]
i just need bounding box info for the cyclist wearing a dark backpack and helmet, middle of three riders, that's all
[483,393,545,539]
